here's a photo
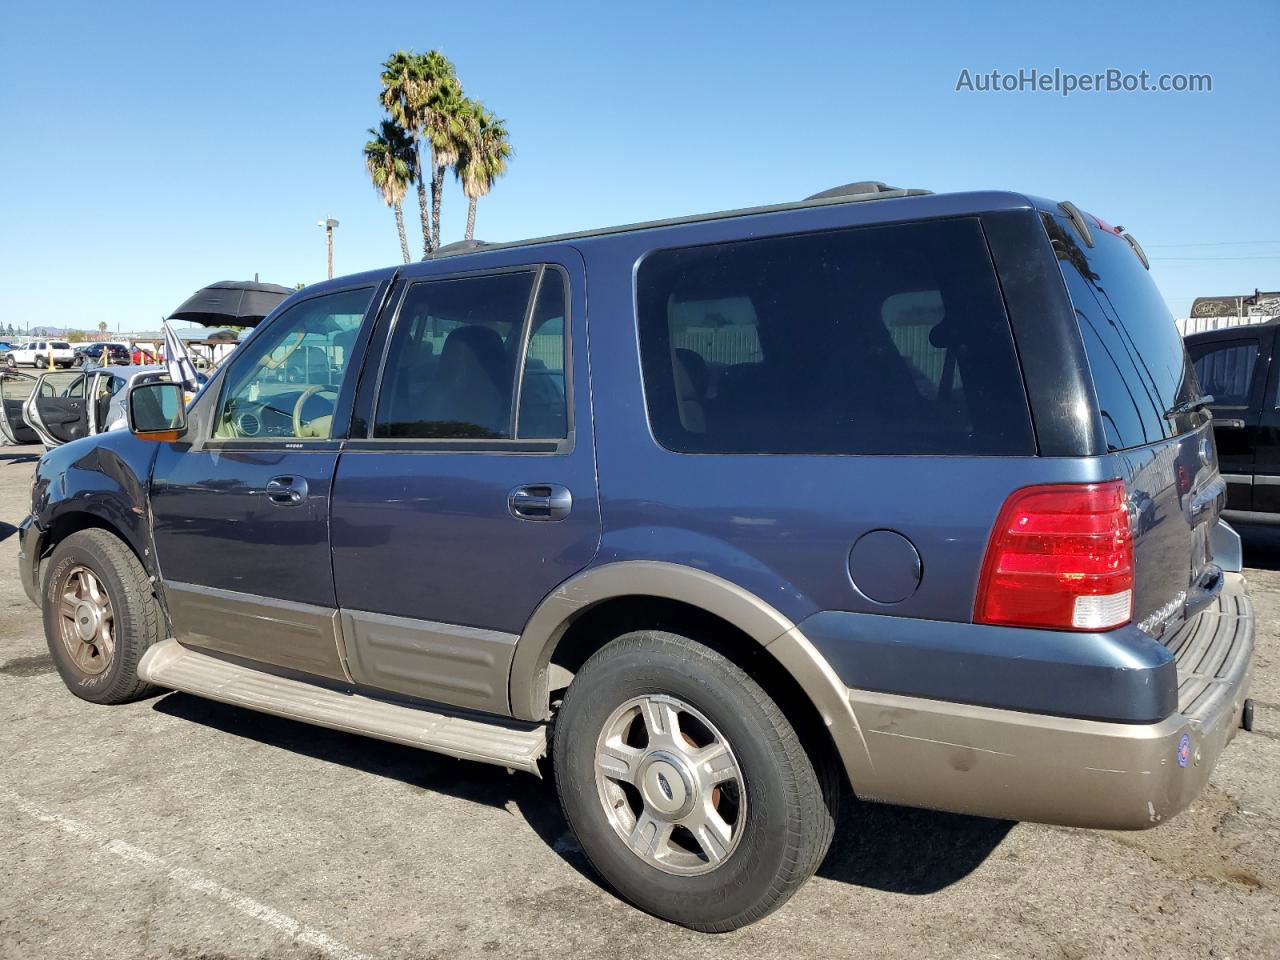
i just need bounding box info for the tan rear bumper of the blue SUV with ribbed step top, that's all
[829,573,1254,829]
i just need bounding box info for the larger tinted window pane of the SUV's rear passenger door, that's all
[374,270,540,439]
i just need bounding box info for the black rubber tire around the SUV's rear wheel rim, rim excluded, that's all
[553,631,838,933]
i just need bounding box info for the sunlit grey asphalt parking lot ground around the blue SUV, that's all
[0,447,1280,960]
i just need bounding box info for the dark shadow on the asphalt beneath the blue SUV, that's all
[155,692,1014,895]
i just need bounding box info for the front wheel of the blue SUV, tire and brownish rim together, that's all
[42,530,164,704]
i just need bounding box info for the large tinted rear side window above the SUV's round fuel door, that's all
[637,219,1034,454]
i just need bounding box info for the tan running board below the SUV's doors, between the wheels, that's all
[138,639,547,776]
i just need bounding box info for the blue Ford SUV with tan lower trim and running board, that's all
[20,183,1253,931]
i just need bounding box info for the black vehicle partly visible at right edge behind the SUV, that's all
[1187,320,1280,524]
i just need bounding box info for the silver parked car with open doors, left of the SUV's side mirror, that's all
[0,366,169,449]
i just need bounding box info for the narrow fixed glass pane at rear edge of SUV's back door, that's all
[516,269,568,439]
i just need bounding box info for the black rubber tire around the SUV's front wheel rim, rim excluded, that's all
[41,530,164,704]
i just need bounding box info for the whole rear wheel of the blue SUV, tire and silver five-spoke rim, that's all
[554,631,838,932]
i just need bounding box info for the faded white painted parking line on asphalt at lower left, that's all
[0,788,370,960]
